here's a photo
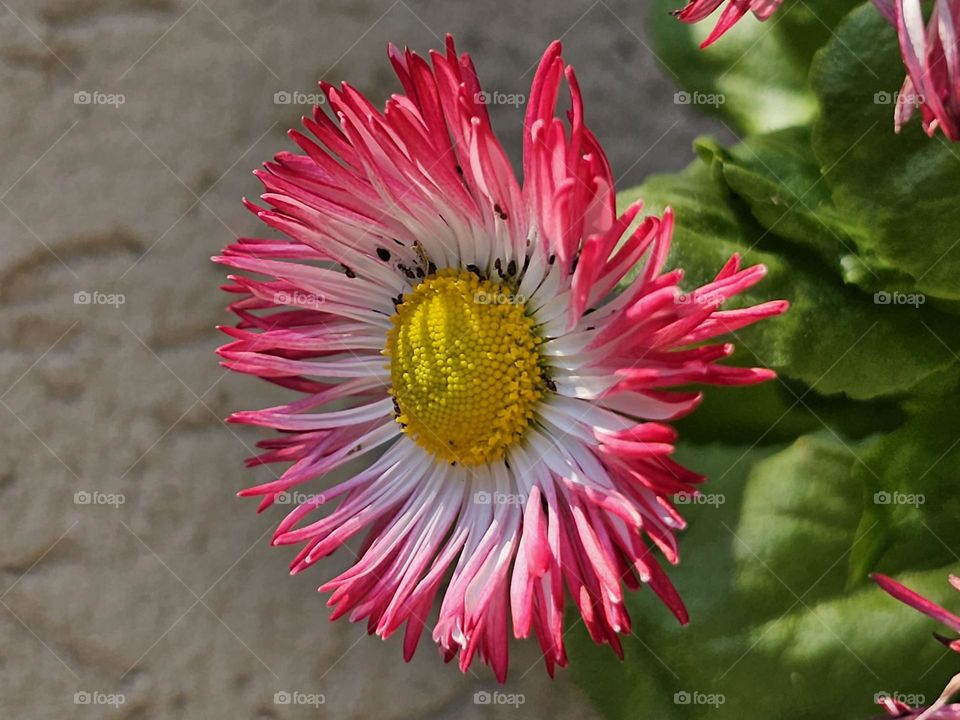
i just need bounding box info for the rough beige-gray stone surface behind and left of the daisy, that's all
[0,0,715,720]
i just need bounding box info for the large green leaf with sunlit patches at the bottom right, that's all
[569,436,960,720]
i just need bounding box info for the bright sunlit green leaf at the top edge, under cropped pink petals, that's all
[650,0,861,132]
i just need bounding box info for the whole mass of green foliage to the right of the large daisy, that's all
[569,0,960,720]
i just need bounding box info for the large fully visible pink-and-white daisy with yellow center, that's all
[215,39,786,681]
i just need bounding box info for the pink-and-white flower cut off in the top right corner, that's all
[874,0,960,140]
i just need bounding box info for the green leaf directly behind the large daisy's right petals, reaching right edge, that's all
[620,162,960,402]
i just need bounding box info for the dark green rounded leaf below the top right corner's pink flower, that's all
[811,6,960,300]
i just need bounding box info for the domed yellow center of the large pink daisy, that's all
[383,268,544,465]
